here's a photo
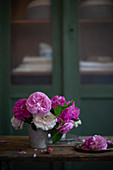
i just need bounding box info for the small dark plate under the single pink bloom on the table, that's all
[75,144,113,153]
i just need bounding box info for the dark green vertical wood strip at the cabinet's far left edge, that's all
[0,1,10,134]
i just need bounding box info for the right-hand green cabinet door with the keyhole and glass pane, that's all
[63,0,113,135]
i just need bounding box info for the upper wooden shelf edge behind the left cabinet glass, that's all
[11,20,51,24]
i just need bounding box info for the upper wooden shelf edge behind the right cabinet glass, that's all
[80,19,113,23]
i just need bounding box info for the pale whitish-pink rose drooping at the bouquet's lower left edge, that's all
[11,116,24,130]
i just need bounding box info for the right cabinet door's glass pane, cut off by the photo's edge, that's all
[79,0,113,84]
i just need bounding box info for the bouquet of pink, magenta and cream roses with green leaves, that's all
[11,92,81,143]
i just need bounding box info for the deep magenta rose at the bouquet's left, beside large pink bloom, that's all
[13,99,31,120]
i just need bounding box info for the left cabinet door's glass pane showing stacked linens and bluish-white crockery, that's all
[11,0,52,85]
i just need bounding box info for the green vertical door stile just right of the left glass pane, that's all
[52,0,63,95]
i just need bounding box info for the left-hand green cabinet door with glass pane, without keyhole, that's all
[0,0,62,134]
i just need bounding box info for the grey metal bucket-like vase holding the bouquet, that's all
[28,124,48,148]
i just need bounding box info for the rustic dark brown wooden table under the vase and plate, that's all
[0,136,113,169]
